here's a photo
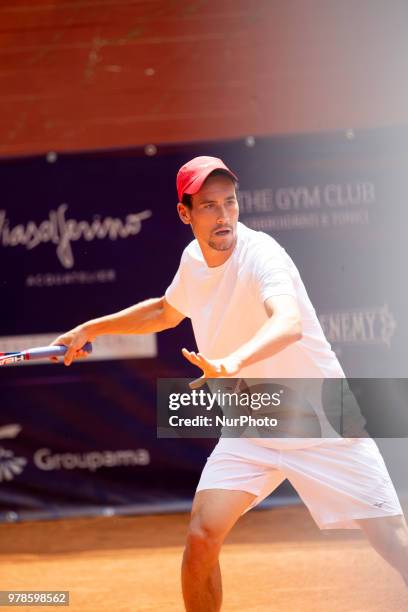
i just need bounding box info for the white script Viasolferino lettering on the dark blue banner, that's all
[0,204,152,268]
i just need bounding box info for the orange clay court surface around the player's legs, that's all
[0,506,408,612]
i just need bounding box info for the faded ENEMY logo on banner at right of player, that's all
[319,304,397,346]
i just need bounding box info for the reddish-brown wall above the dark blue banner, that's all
[0,0,408,156]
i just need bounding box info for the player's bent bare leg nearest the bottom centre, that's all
[182,489,255,612]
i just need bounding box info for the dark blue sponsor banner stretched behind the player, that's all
[0,129,408,520]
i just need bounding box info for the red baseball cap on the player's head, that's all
[177,155,238,202]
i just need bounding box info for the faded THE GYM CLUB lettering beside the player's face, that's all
[239,181,376,231]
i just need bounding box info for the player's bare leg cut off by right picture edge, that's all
[357,515,408,586]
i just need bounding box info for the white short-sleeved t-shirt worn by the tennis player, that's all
[165,223,344,448]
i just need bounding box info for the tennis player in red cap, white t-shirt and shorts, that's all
[54,157,408,612]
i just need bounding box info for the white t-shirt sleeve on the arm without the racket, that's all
[254,241,297,302]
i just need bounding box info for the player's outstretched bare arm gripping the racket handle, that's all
[53,297,184,365]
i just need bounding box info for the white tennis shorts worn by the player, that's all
[197,438,402,529]
